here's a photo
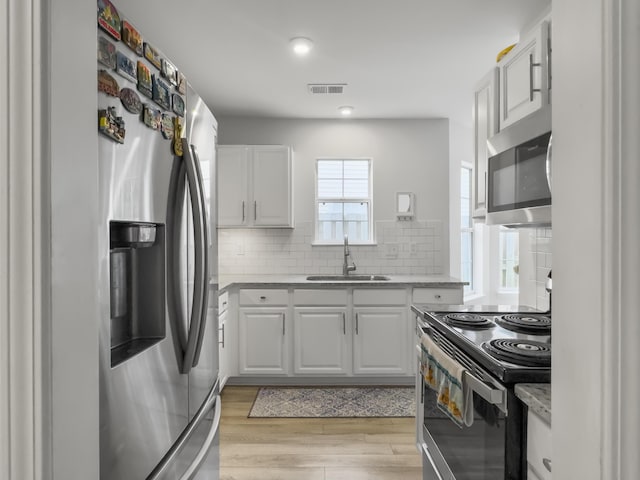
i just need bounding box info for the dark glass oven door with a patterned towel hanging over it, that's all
[422,350,510,480]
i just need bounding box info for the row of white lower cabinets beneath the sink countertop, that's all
[230,287,462,378]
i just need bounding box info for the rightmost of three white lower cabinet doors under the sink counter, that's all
[353,307,409,375]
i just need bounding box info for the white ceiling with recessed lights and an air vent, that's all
[119,0,551,124]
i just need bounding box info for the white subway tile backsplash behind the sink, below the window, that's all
[218,221,444,275]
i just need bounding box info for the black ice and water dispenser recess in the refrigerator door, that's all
[109,221,166,367]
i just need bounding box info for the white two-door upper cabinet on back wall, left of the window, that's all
[218,145,293,227]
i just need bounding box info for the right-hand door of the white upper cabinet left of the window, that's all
[251,145,293,227]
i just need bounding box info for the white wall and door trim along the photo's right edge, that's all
[552,0,640,480]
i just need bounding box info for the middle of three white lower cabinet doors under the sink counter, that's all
[293,307,349,374]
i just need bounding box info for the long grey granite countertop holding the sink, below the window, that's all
[218,274,466,292]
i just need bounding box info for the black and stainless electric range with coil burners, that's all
[411,305,551,480]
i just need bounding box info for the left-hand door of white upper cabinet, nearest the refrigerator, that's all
[218,145,250,227]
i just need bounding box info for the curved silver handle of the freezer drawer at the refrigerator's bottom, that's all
[146,380,222,480]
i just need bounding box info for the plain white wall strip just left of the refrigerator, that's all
[48,0,99,480]
